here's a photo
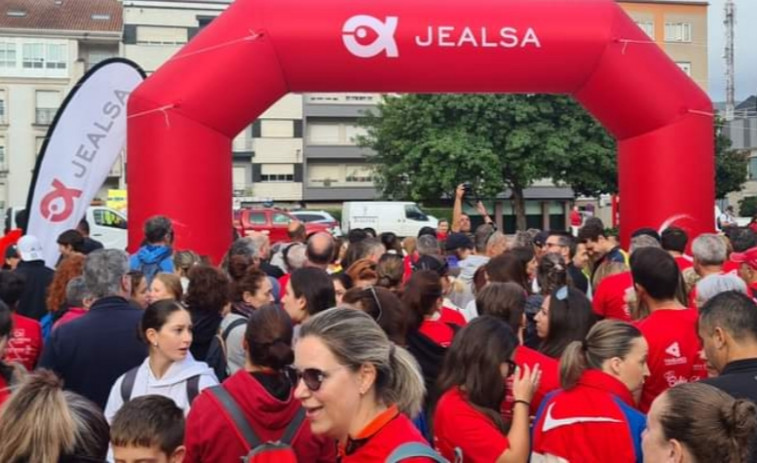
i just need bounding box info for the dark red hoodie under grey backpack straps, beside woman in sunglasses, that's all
[184,370,336,463]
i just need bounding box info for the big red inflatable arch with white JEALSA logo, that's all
[128,0,714,259]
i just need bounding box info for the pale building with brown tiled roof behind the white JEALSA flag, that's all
[0,0,122,210]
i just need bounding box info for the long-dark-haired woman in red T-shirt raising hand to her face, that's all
[434,315,536,463]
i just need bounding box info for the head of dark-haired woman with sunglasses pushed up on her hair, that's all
[534,286,597,359]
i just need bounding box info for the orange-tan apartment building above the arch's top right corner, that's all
[617,0,709,92]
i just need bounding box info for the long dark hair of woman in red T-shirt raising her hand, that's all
[438,315,518,431]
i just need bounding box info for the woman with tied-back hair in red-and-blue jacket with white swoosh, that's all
[532,320,649,463]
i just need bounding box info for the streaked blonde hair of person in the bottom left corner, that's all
[0,370,109,462]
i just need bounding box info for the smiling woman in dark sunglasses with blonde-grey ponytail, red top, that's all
[295,308,432,463]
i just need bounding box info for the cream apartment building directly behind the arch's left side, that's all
[122,0,303,205]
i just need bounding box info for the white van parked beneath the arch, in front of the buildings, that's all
[342,201,439,236]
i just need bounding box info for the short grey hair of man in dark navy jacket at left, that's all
[83,249,129,299]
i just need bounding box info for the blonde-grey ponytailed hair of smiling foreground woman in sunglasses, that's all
[300,308,426,417]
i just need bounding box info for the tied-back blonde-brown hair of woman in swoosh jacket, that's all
[560,320,642,389]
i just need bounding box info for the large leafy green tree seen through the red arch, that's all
[359,94,617,229]
